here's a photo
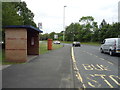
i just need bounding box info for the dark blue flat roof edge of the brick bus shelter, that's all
[3,25,43,33]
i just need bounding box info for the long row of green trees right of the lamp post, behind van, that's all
[65,16,120,42]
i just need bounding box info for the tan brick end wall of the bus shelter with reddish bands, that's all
[5,28,27,62]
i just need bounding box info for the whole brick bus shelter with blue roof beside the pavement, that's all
[4,25,43,62]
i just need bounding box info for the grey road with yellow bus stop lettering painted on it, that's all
[72,45,120,88]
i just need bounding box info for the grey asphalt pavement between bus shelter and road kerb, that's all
[2,45,74,88]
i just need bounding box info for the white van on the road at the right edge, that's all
[100,38,120,56]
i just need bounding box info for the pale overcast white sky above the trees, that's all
[21,0,120,33]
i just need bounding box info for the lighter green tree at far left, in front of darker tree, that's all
[2,2,23,26]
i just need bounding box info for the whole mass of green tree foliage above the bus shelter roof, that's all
[2,2,36,27]
